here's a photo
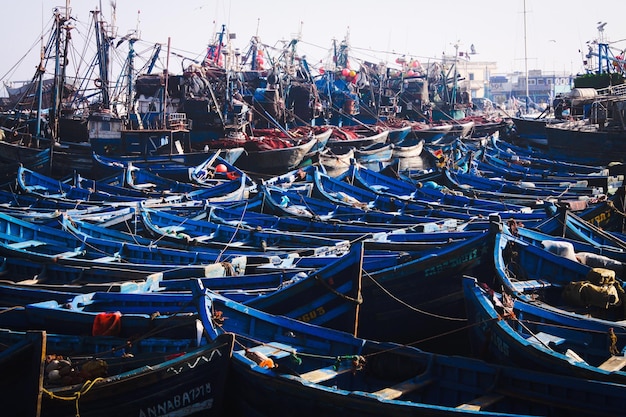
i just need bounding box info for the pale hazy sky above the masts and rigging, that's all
[0,0,626,95]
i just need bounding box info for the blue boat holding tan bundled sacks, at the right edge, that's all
[489,218,626,320]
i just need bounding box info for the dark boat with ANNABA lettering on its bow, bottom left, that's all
[0,330,234,417]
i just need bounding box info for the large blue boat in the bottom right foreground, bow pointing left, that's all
[193,282,626,416]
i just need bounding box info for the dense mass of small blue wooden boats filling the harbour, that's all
[0,125,626,416]
